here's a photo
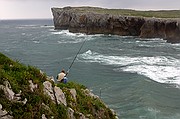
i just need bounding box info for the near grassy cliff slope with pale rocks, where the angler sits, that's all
[0,53,117,119]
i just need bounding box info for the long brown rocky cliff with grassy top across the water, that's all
[51,7,180,43]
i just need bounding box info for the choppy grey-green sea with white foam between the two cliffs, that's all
[0,19,180,119]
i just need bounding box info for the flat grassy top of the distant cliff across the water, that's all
[53,7,180,18]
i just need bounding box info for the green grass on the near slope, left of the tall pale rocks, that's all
[0,53,67,119]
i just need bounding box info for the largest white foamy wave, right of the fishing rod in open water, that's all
[79,50,180,85]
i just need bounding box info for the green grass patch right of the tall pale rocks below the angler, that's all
[57,82,115,119]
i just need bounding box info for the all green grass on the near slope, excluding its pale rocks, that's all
[0,53,115,119]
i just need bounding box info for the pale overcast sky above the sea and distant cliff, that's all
[0,0,180,19]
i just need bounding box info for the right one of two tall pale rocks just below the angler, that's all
[54,86,67,106]
